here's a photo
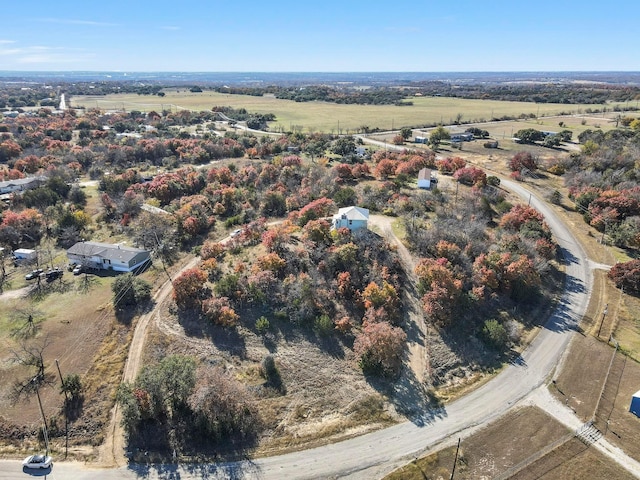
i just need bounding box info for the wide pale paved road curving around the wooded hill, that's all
[0,180,592,480]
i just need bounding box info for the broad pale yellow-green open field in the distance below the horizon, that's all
[69,89,614,134]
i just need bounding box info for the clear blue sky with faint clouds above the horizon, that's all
[0,0,640,72]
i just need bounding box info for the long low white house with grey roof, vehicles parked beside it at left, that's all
[67,242,151,272]
